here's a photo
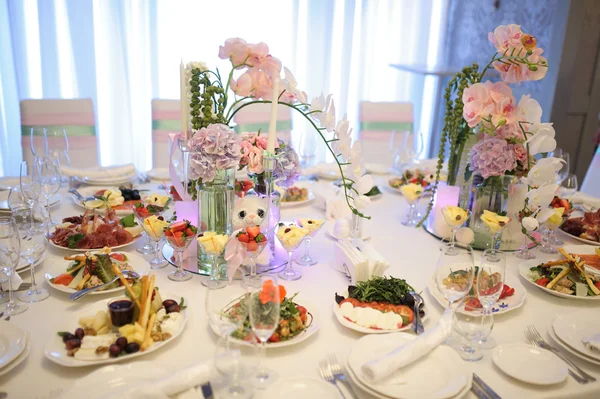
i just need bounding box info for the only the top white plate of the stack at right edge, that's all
[552,312,600,361]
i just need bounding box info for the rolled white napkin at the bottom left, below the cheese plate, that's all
[106,363,210,399]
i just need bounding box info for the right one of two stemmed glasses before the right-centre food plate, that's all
[476,249,506,349]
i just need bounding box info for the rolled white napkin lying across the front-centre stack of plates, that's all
[362,309,453,383]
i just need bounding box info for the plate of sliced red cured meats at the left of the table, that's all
[49,208,142,252]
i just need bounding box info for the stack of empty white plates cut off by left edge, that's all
[0,320,31,376]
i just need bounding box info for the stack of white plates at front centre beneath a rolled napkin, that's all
[347,334,473,399]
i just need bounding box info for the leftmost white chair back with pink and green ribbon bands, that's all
[20,98,98,168]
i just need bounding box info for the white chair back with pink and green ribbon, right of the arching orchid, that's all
[359,101,413,166]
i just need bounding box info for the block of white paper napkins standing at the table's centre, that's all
[335,238,390,284]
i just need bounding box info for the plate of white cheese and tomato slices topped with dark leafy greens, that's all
[333,277,427,334]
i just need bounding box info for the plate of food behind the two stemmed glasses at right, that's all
[427,267,527,316]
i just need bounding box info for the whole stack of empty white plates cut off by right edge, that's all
[548,313,600,365]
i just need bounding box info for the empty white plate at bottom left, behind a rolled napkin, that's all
[61,362,169,399]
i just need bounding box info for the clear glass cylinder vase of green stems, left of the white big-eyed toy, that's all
[197,169,234,278]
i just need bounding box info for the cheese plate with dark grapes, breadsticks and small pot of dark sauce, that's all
[44,276,188,367]
